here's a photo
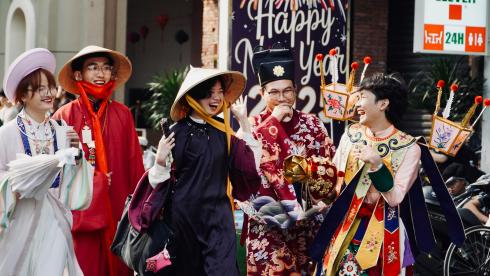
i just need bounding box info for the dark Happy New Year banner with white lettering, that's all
[231,0,348,122]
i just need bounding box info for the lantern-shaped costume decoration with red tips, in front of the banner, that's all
[316,49,371,121]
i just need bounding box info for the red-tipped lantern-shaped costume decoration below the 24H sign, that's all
[429,80,490,156]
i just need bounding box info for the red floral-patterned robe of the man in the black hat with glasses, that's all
[241,110,335,275]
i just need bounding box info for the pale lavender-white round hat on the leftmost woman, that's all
[3,48,56,103]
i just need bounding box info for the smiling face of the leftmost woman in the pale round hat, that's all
[21,72,56,114]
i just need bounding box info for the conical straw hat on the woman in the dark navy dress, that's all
[170,66,247,122]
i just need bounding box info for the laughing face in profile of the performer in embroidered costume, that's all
[356,90,389,127]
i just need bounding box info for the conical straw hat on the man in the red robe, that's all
[58,45,132,94]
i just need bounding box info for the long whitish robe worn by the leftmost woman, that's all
[0,112,93,276]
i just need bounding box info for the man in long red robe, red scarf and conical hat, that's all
[53,45,144,276]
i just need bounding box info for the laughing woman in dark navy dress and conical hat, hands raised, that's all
[147,67,261,276]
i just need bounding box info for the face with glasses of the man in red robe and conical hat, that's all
[75,57,113,86]
